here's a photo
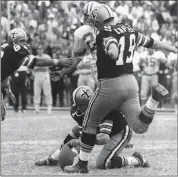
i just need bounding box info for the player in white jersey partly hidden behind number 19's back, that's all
[74,24,96,90]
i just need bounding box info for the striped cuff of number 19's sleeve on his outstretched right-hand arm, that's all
[136,32,153,48]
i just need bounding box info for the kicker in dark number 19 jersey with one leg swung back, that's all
[64,5,177,173]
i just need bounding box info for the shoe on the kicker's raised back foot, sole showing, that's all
[152,83,169,101]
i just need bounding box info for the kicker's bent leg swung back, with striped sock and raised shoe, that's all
[119,75,167,134]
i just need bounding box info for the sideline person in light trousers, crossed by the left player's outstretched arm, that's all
[34,45,52,114]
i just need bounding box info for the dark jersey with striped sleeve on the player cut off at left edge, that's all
[1,44,36,82]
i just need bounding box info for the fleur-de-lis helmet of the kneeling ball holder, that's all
[72,85,93,106]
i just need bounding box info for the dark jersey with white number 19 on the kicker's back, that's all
[96,23,151,79]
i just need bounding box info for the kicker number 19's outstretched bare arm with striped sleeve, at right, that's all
[136,32,177,53]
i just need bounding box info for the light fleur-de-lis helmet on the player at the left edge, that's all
[8,28,27,45]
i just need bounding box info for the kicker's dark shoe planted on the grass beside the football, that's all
[64,161,89,173]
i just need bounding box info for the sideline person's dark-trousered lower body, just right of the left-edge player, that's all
[11,66,29,113]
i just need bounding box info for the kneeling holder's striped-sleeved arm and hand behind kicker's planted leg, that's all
[95,120,113,145]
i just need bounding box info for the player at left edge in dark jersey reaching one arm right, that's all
[1,28,72,120]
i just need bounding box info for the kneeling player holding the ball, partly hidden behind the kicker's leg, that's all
[35,86,149,169]
